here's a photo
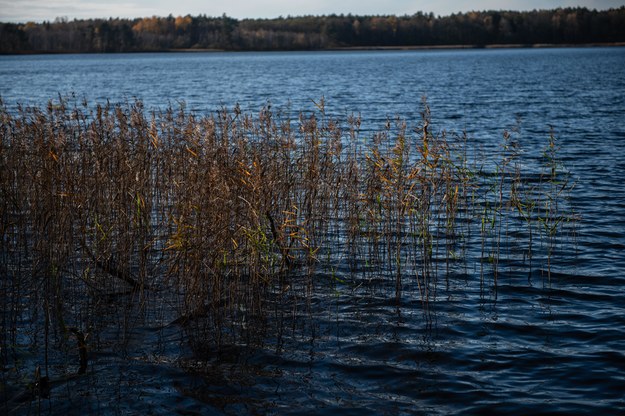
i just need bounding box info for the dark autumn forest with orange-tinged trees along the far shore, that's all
[0,6,625,53]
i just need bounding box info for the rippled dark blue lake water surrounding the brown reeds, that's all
[0,48,625,415]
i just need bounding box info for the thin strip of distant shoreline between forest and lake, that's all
[0,42,625,56]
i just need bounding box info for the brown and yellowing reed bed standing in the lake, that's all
[0,99,574,394]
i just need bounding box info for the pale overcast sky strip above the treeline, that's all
[0,0,625,22]
